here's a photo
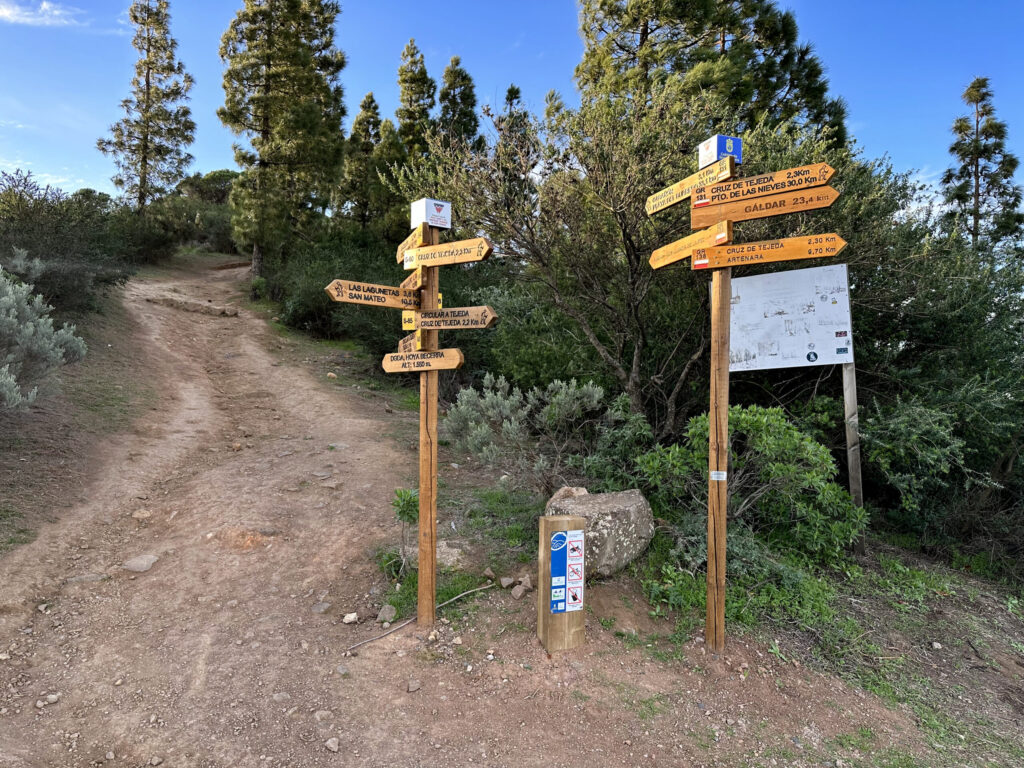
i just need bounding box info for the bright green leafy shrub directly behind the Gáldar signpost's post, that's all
[636,406,866,563]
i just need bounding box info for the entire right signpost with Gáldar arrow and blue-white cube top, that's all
[645,136,846,653]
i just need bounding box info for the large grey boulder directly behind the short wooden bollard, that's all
[546,490,654,577]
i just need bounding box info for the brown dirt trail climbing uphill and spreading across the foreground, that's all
[0,262,929,768]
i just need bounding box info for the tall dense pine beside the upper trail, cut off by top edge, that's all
[217,0,345,276]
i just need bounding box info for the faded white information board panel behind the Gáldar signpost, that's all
[729,264,853,371]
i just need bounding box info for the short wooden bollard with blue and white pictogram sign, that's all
[537,515,587,653]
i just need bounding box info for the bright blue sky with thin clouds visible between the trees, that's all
[0,0,1024,191]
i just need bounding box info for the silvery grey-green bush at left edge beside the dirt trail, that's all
[0,268,86,412]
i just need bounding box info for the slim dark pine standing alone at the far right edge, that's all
[942,78,1024,250]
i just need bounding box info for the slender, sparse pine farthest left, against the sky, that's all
[96,0,196,211]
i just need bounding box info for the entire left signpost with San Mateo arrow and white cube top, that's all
[326,199,498,627]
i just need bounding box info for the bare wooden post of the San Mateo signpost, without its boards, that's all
[416,227,440,627]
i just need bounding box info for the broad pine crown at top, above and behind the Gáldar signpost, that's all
[575,0,846,144]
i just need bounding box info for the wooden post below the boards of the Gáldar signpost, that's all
[705,267,732,653]
